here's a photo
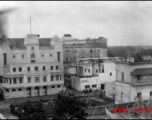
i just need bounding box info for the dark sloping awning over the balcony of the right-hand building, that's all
[131,68,152,76]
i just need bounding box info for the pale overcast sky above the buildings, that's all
[0,1,152,46]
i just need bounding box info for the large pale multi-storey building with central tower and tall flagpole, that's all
[0,34,64,98]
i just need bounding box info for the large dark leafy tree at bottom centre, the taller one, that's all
[51,91,88,119]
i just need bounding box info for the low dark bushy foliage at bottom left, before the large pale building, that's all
[14,102,46,119]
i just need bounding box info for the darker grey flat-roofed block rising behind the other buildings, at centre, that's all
[62,34,107,62]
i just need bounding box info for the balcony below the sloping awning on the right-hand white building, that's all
[131,79,152,86]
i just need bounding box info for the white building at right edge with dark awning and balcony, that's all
[106,62,152,103]
